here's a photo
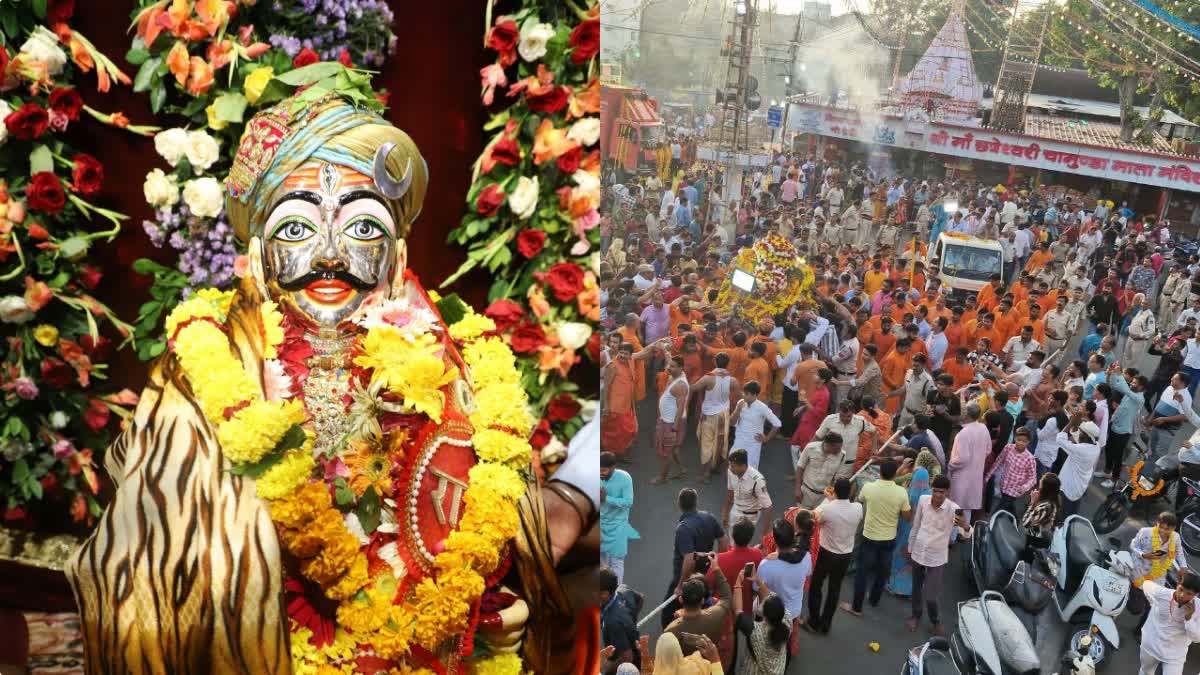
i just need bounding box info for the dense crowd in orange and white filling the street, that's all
[601,148,1200,675]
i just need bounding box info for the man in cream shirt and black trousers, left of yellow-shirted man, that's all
[809,478,863,634]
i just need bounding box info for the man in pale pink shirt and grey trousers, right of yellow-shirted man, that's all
[904,473,971,635]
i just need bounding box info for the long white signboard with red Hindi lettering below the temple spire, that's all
[790,103,1200,192]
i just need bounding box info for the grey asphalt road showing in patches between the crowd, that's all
[625,319,1200,675]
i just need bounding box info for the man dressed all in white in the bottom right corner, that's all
[1138,572,1200,675]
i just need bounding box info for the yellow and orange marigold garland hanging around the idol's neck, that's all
[167,289,534,675]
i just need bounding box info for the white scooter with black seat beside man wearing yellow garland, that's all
[1050,515,1129,664]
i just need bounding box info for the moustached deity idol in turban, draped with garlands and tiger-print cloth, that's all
[67,94,599,675]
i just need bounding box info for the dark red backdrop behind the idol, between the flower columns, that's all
[71,0,488,390]
